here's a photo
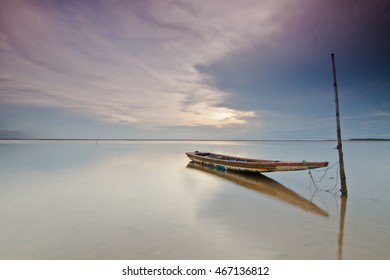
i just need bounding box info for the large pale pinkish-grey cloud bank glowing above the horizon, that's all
[0,0,290,127]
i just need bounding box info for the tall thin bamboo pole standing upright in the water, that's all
[331,53,348,196]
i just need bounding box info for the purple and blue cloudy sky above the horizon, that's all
[0,0,390,140]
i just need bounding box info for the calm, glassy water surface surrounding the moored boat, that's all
[0,141,390,260]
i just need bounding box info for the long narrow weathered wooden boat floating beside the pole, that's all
[186,151,328,173]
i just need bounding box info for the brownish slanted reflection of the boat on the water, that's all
[187,161,329,217]
